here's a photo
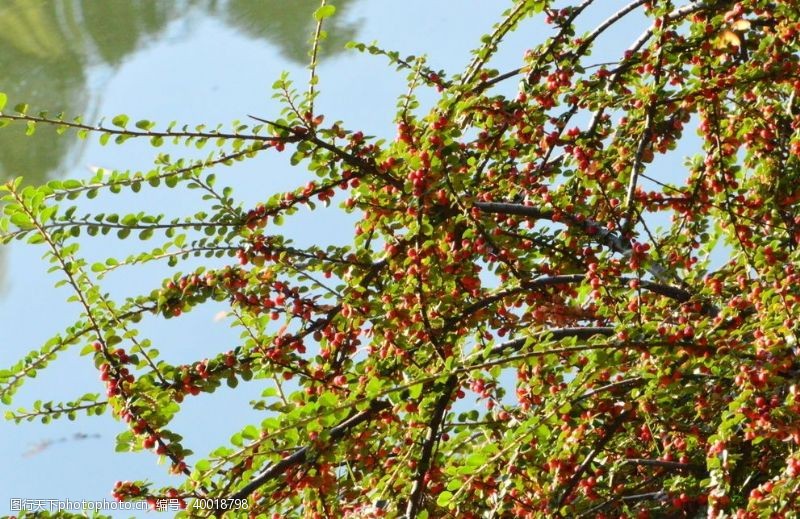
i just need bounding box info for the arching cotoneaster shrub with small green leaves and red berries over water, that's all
[0,0,800,518]
